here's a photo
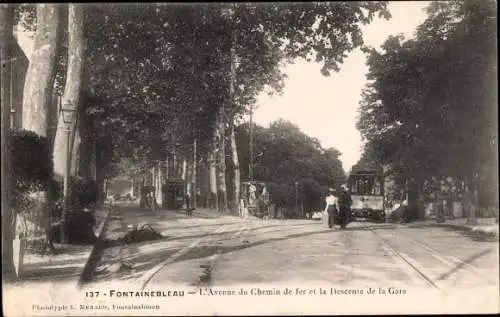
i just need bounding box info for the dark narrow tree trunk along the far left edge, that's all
[0,4,15,280]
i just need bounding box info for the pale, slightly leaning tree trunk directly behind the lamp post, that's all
[53,4,85,178]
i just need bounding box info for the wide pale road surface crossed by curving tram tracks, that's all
[81,202,499,313]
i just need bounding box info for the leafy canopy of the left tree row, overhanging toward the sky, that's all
[77,2,388,177]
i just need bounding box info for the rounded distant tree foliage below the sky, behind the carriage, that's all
[237,120,345,208]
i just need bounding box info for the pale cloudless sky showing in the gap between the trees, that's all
[253,1,429,171]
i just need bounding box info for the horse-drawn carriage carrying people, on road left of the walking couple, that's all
[240,181,270,218]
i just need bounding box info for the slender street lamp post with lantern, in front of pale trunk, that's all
[59,101,75,244]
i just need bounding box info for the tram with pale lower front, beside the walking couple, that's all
[348,166,385,221]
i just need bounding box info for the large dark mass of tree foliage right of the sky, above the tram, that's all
[358,1,496,183]
